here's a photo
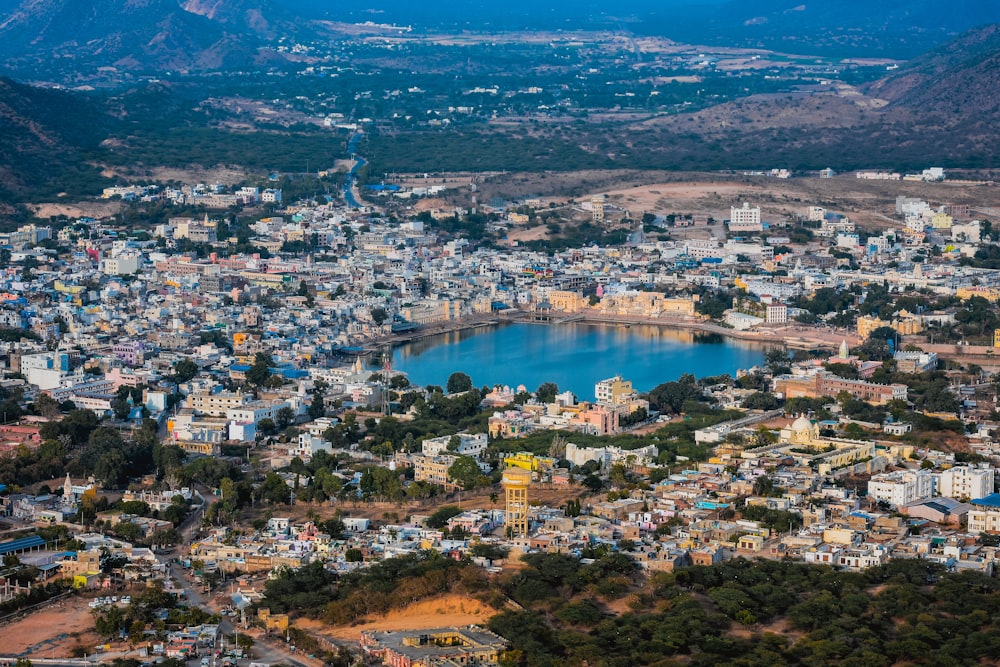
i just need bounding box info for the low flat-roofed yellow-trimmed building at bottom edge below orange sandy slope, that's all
[361,625,507,667]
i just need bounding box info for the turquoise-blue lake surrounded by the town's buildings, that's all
[392,322,764,400]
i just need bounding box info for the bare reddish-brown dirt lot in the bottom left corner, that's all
[0,597,99,658]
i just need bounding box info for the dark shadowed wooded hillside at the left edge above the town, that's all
[0,77,112,200]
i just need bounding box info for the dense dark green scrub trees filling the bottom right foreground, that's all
[489,555,1000,667]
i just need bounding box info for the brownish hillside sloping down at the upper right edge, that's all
[868,23,1000,119]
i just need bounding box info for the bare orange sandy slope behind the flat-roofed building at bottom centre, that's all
[295,595,497,642]
